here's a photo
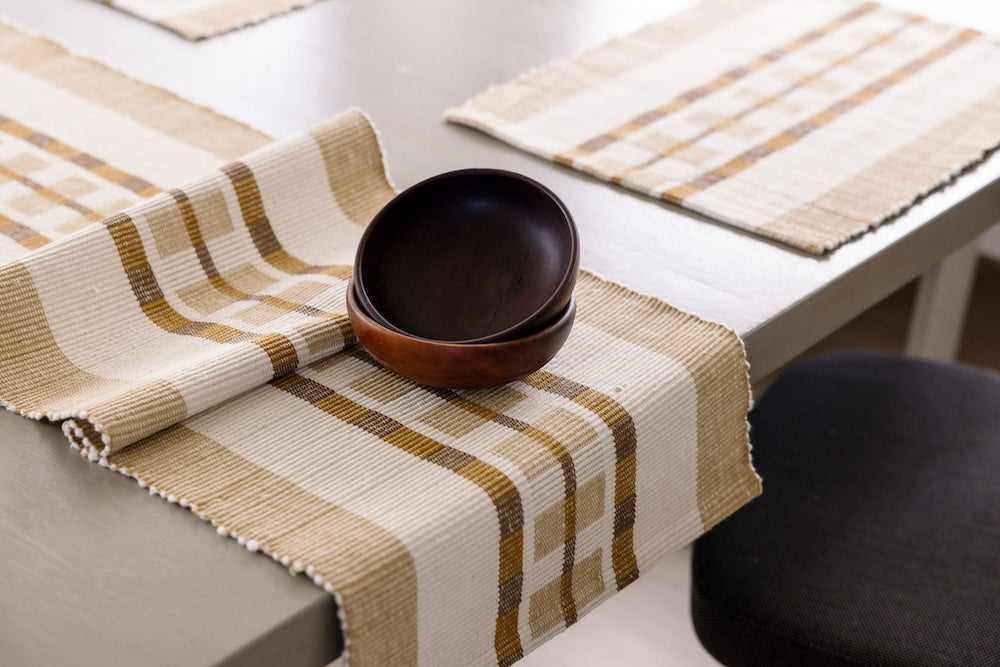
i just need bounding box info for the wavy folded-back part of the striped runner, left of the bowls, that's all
[0,111,393,457]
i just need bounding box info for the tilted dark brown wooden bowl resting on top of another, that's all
[354,169,580,343]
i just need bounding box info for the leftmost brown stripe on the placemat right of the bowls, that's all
[553,2,878,169]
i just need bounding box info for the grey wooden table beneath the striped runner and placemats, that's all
[0,0,1000,665]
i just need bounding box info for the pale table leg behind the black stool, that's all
[906,241,978,361]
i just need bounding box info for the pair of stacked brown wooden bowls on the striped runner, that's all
[347,169,580,389]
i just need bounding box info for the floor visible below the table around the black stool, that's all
[518,260,1000,667]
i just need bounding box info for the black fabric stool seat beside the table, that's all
[691,353,1000,667]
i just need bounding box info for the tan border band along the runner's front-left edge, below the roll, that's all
[109,425,418,665]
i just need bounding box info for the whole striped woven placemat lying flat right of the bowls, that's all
[447,0,1000,254]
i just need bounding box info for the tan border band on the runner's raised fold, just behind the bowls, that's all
[309,110,396,226]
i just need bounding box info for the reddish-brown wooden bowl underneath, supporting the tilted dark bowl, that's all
[347,281,576,389]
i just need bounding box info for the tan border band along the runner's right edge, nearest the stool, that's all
[576,272,761,532]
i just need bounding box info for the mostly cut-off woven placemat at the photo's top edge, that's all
[97,0,316,40]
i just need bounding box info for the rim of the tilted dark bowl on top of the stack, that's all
[351,167,580,345]
